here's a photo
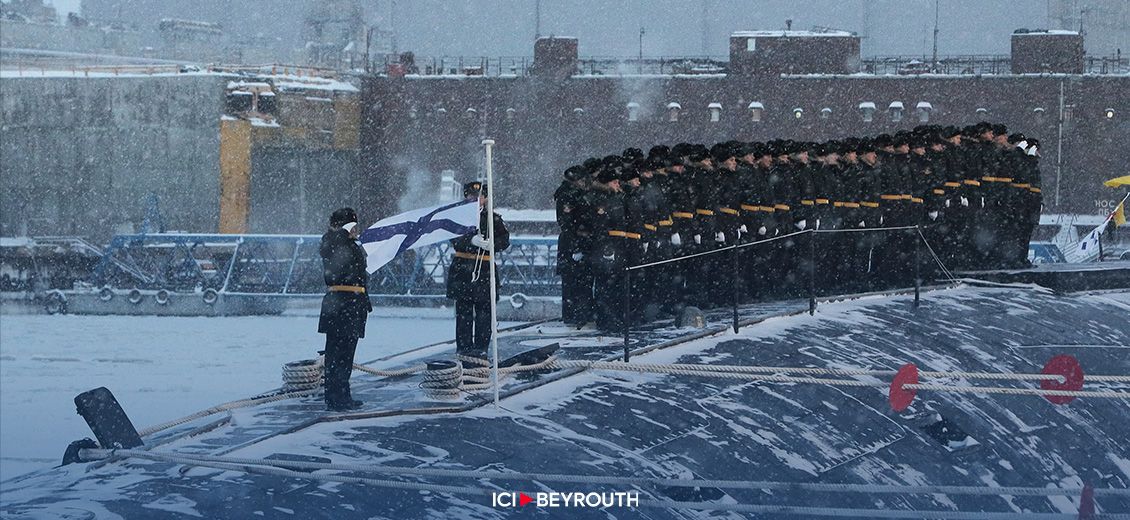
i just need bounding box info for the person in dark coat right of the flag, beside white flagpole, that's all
[447,182,510,357]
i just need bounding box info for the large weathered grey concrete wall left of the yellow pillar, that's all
[0,75,229,241]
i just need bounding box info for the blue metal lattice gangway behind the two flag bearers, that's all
[90,233,560,296]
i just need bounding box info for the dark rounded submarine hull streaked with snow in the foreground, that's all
[0,286,1130,518]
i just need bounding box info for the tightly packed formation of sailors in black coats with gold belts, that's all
[554,123,1042,330]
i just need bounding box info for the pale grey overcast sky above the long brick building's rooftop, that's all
[51,0,1071,57]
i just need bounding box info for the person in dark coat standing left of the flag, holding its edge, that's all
[318,208,373,411]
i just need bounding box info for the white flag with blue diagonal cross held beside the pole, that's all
[359,199,479,272]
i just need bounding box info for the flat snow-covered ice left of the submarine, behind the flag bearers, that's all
[0,309,481,480]
